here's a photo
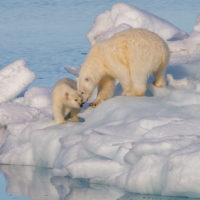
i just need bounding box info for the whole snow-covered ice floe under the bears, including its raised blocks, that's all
[0,4,200,199]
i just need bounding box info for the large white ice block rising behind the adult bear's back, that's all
[87,3,188,45]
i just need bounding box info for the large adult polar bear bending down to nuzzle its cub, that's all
[78,28,169,106]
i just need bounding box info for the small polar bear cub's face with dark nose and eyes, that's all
[64,92,83,108]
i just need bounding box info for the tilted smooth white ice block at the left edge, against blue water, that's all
[0,60,35,102]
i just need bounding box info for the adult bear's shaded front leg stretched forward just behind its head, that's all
[90,76,115,107]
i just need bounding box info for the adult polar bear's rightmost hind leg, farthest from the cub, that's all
[153,64,166,87]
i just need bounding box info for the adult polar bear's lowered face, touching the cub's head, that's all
[77,76,94,103]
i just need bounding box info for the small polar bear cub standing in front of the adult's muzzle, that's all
[52,78,82,124]
